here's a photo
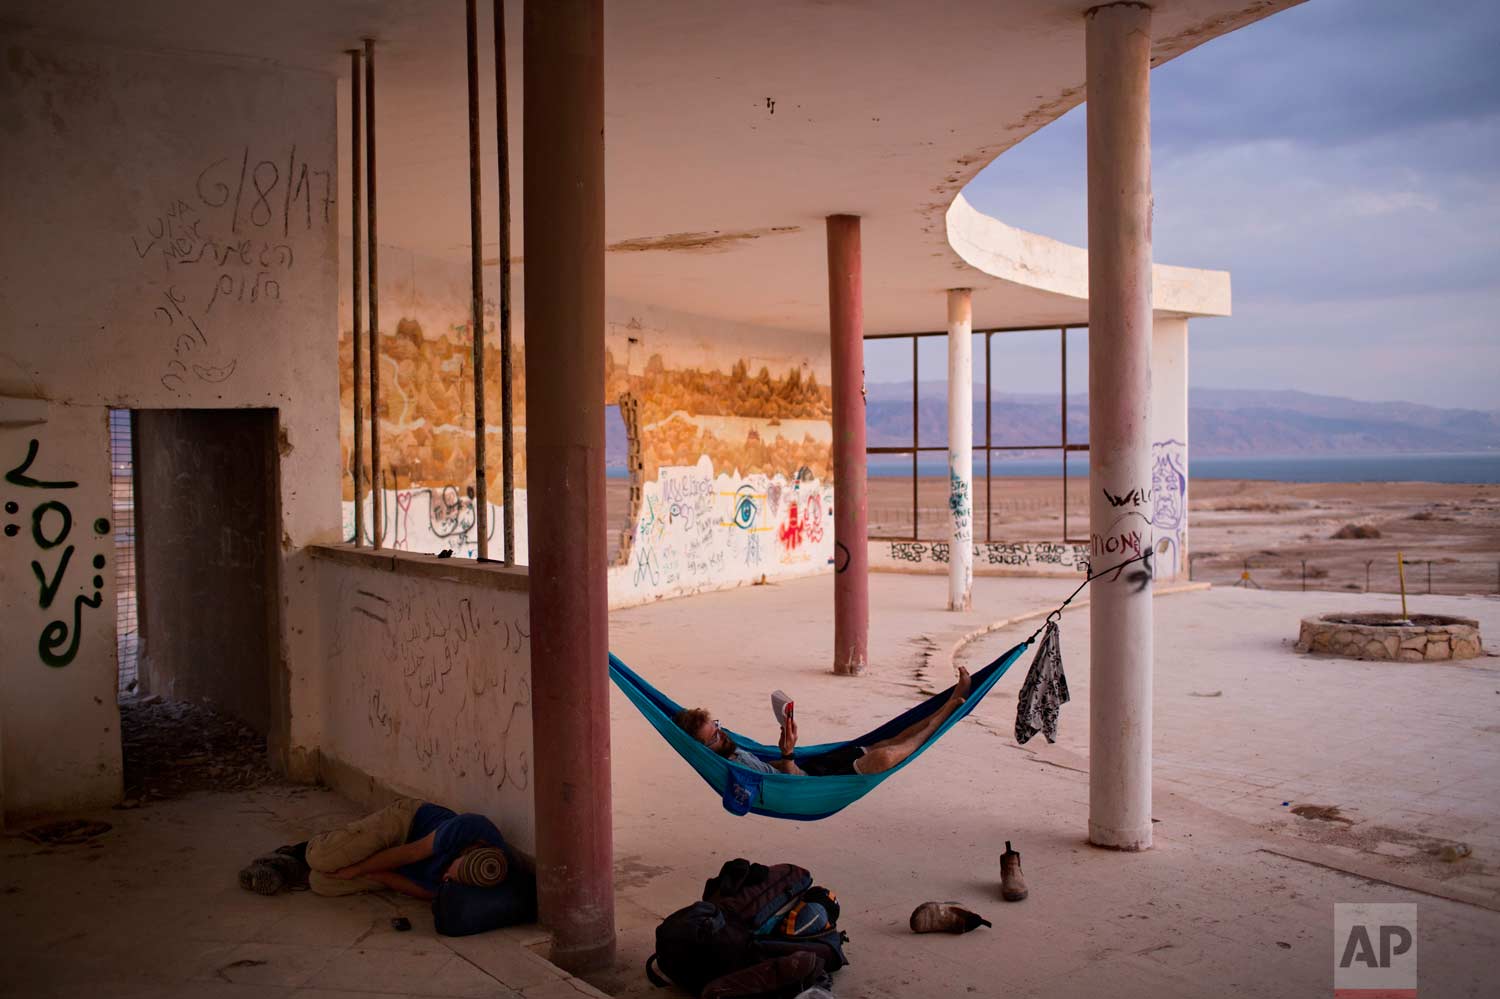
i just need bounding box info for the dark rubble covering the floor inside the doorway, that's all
[119,696,282,809]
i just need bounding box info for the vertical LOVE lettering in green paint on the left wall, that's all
[5,438,110,666]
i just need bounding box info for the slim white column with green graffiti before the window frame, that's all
[948,288,974,611]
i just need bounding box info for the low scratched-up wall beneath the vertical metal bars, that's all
[317,549,536,854]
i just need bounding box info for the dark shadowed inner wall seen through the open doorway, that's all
[134,410,281,732]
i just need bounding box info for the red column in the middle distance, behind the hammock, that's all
[828,215,870,677]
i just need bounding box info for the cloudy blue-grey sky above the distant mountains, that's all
[954,0,1500,410]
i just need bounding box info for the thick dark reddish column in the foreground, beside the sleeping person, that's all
[522,0,615,971]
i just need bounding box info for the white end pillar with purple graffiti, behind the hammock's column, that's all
[1151,317,1188,582]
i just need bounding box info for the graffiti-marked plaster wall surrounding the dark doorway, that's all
[0,32,339,818]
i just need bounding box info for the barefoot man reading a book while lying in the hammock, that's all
[675,666,971,777]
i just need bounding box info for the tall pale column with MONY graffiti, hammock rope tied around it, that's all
[1085,3,1154,851]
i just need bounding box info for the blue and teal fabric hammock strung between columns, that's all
[609,636,1035,822]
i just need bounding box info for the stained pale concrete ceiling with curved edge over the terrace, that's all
[6,0,1298,333]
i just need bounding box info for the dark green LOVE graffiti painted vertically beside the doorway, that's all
[5,438,110,668]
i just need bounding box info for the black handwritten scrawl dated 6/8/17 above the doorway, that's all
[131,144,335,395]
